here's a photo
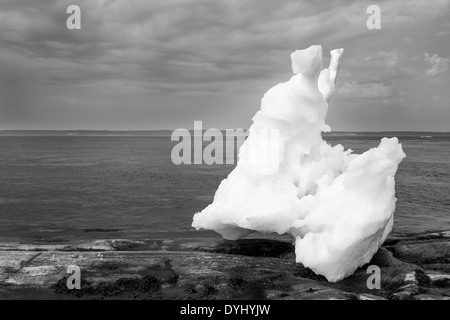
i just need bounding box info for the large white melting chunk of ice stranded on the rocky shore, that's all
[192,45,405,282]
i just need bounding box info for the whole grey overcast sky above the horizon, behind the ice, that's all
[0,0,450,131]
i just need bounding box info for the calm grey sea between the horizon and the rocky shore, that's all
[0,131,450,242]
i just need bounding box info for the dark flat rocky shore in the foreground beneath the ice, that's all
[0,231,450,300]
